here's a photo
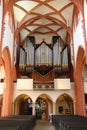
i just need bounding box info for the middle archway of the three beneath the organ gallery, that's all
[35,94,53,120]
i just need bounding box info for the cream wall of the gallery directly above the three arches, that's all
[13,83,74,102]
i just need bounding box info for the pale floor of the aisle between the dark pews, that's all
[33,120,55,130]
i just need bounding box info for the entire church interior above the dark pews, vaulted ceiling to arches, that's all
[0,0,87,123]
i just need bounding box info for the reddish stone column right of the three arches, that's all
[74,46,86,116]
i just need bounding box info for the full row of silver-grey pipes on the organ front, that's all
[19,38,68,69]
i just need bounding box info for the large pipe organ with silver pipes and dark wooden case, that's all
[19,36,69,75]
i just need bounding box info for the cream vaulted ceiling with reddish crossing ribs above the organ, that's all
[14,0,74,44]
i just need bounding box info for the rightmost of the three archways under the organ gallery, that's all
[56,93,74,115]
